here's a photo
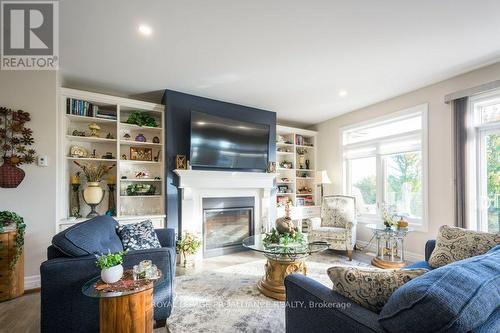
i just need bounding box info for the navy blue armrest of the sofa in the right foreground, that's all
[285,274,384,333]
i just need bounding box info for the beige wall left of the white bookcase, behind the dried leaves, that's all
[0,71,57,288]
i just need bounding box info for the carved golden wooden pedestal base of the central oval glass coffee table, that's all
[257,258,307,301]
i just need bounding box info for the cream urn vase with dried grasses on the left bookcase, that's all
[74,161,115,217]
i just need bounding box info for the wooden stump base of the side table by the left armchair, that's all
[99,288,154,333]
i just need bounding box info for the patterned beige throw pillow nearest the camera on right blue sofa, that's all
[327,266,427,313]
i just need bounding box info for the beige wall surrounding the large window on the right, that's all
[315,63,500,255]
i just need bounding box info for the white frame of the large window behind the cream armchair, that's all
[339,103,429,232]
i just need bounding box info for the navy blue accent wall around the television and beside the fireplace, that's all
[162,90,276,230]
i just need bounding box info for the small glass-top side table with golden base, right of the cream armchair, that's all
[366,224,413,269]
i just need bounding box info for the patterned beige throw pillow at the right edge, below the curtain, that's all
[429,225,500,268]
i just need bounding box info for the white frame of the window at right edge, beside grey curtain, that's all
[467,90,500,231]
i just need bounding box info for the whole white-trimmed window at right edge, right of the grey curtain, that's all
[469,91,500,232]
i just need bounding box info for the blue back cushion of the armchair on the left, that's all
[52,216,123,257]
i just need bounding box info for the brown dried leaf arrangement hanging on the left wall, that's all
[0,107,36,166]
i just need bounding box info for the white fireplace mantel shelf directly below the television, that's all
[174,170,276,189]
